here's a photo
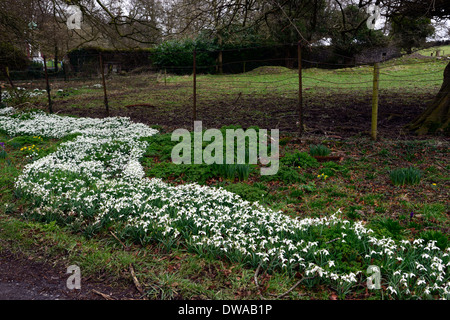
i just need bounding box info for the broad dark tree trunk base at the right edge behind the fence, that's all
[406,63,450,135]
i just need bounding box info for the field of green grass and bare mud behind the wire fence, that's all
[5,55,447,137]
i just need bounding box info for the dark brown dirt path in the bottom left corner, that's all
[0,250,139,300]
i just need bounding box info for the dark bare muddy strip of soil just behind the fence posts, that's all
[54,92,440,139]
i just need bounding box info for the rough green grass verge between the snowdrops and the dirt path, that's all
[0,213,276,300]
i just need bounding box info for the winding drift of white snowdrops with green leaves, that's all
[0,108,450,299]
